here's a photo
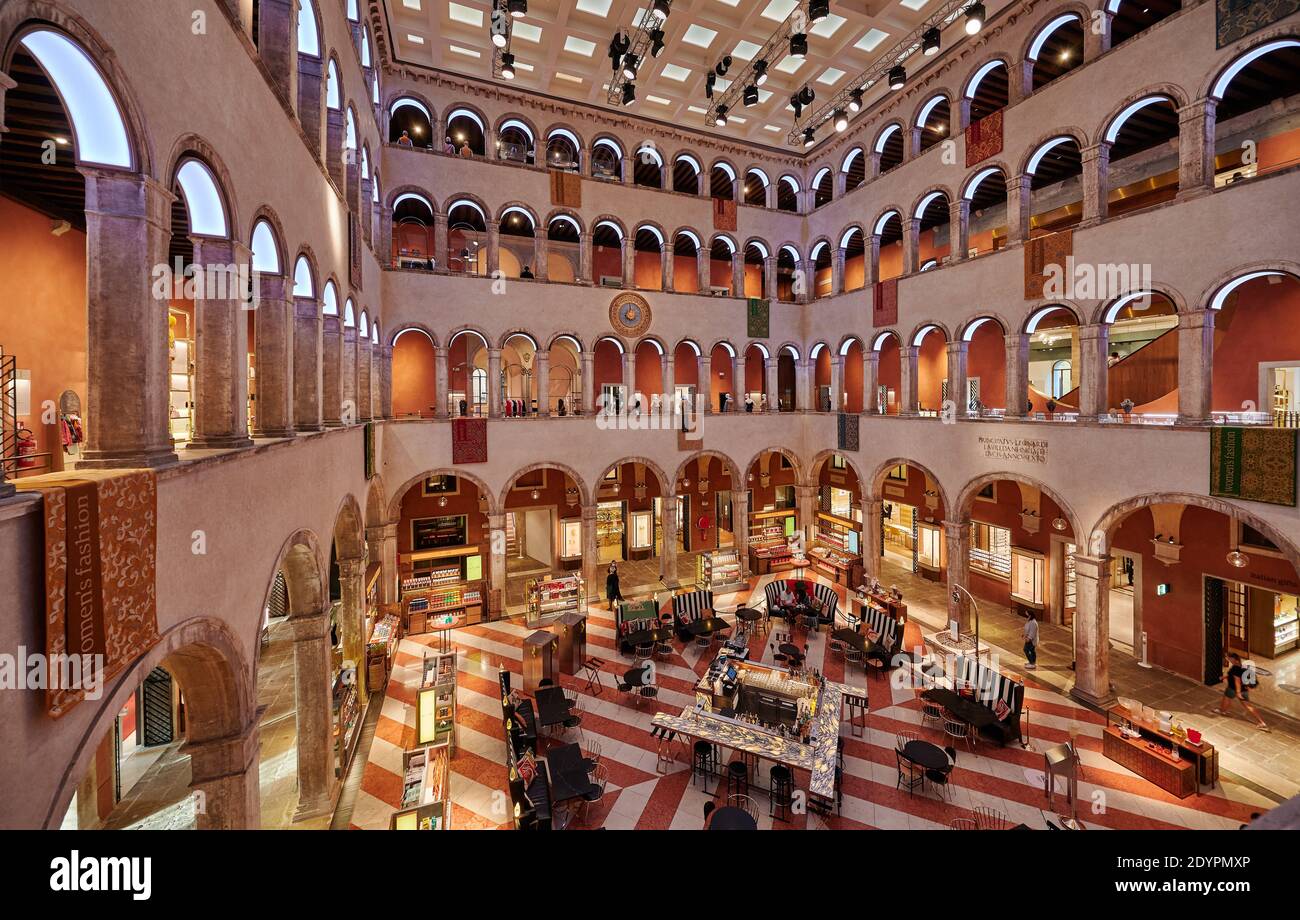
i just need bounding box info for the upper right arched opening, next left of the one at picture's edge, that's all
[1104,96,1179,214]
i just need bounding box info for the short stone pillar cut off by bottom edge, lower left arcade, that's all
[181,720,261,830]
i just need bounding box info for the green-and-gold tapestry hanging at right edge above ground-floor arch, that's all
[1210,428,1296,508]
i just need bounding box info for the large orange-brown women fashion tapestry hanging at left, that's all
[13,470,159,719]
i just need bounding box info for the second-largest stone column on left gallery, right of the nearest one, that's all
[190,236,252,450]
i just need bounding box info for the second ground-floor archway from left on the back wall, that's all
[504,464,585,618]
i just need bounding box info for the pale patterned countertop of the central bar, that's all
[654,659,867,799]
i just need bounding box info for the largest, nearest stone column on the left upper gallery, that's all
[74,166,177,467]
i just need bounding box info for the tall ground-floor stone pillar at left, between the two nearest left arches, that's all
[289,610,335,821]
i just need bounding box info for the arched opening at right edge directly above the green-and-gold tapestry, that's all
[1210,270,1300,428]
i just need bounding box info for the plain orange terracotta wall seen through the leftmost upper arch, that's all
[0,198,94,469]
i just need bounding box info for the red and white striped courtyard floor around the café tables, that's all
[352,578,1273,829]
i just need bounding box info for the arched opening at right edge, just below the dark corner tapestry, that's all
[1210,38,1300,186]
